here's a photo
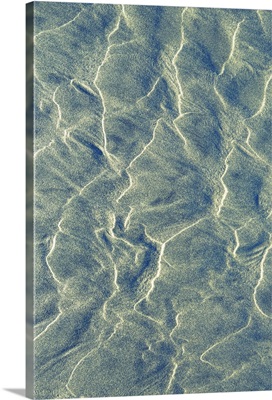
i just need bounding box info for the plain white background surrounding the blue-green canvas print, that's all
[0,0,272,400]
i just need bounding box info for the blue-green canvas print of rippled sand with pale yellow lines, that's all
[27,2,272,399]
